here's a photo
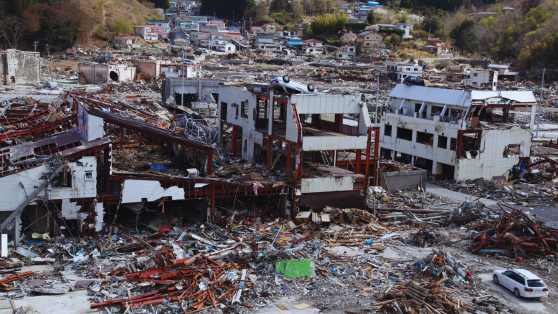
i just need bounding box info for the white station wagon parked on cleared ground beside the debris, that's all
[492,269,548,298]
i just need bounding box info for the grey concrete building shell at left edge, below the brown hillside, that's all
[1,51,41,85]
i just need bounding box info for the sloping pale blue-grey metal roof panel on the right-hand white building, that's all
[389,84,471,107]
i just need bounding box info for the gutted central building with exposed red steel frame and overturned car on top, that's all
[219,78,378,214]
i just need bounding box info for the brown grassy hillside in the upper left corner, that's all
[0,0,154,52]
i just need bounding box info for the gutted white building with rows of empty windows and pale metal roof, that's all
[380,84,537,181]
